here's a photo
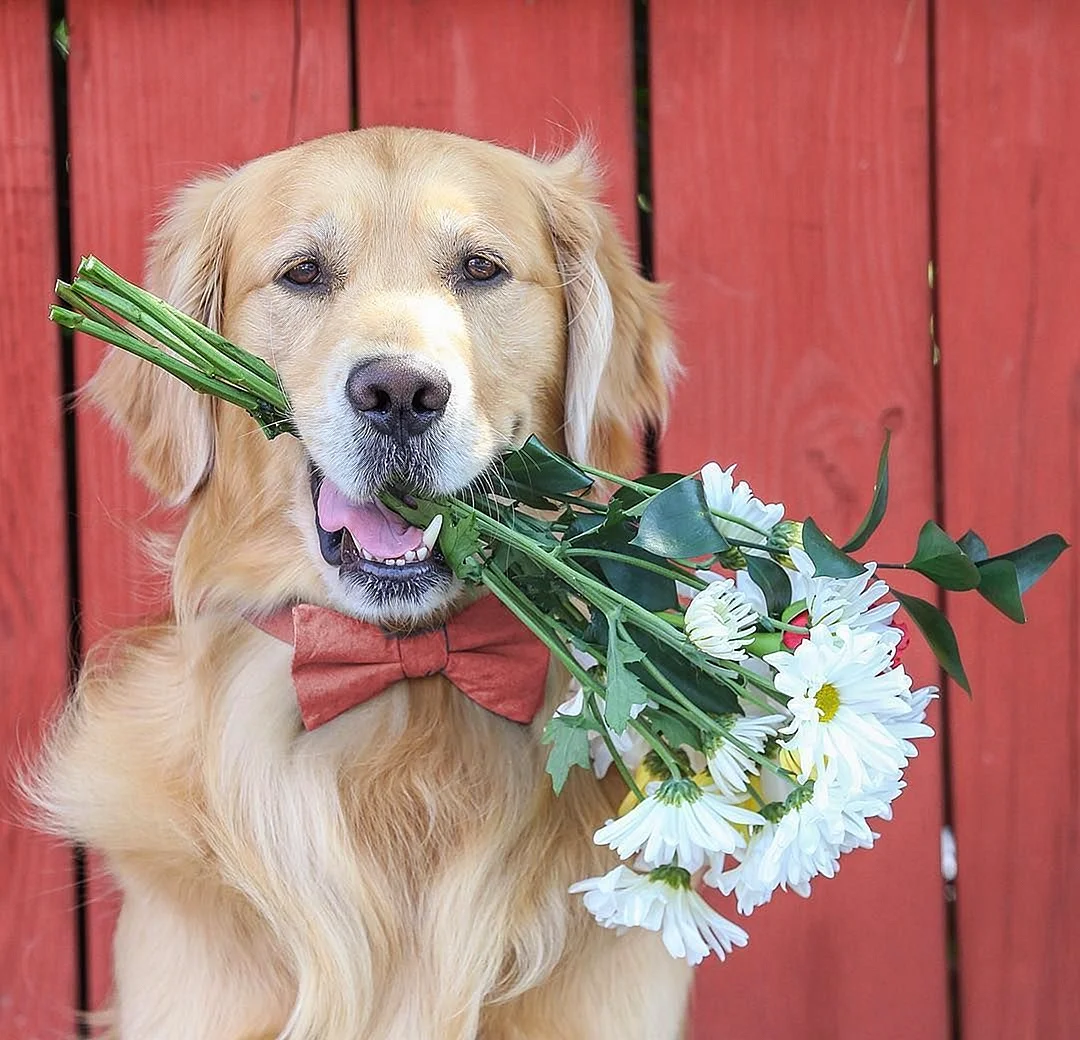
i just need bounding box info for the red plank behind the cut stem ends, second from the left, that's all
[67,0,350,1004]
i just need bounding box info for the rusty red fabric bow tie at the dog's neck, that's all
[255,596,548,730]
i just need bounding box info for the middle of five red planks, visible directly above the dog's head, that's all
[356,0,637,242]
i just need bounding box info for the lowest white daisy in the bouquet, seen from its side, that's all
[570,865,747,964]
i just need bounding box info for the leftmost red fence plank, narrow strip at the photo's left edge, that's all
[0,0,77,1040]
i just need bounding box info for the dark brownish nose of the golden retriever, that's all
[345,357,450,444]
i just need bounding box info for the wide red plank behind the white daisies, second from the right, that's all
[649,0,948,1040]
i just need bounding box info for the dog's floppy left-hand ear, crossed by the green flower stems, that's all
[87,174,229,505]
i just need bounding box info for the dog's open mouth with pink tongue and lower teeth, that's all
[311,468,450,594]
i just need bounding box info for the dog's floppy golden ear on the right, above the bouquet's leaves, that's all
[533,143,676,472]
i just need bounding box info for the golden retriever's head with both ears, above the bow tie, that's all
[92,127,671,625]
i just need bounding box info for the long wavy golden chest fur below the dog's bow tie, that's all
[54,618,607,1037]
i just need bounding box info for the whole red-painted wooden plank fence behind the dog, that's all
[0,0,1080,1040]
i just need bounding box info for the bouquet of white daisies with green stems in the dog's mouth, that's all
[51,257,1066,963]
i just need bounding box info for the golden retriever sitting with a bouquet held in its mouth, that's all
[35,127,690,1040]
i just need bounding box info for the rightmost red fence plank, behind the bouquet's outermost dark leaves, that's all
[936,0,1080,1040]
